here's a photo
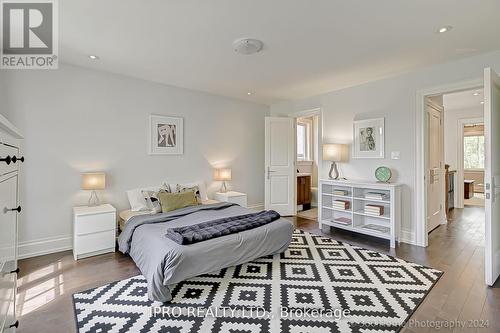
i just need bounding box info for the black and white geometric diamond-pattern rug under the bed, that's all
[73,230,442,333]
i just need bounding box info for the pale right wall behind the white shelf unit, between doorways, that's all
[271,52,500,242]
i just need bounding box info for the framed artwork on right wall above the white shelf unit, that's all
[352,118,385,158]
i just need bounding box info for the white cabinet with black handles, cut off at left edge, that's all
[0,115,24,332]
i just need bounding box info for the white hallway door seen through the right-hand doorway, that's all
[426,101,444,233]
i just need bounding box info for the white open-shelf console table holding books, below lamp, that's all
[318,179,401,248]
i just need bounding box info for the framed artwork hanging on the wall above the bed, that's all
[149,115,184,155]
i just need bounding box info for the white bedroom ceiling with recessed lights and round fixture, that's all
[59,0,500,104]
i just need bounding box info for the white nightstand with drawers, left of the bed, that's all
[73,204,116,260]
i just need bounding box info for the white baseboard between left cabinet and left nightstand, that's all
[18,236,73,259]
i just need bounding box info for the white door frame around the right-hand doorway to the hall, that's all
[414,77,484,247]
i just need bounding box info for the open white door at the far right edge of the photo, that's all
[484,68,500,286]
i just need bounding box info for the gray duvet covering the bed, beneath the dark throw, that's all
[118,203,293,302]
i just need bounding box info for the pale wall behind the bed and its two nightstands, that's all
[0,65,269,256]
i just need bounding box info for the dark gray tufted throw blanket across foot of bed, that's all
[166,210,280,245]
